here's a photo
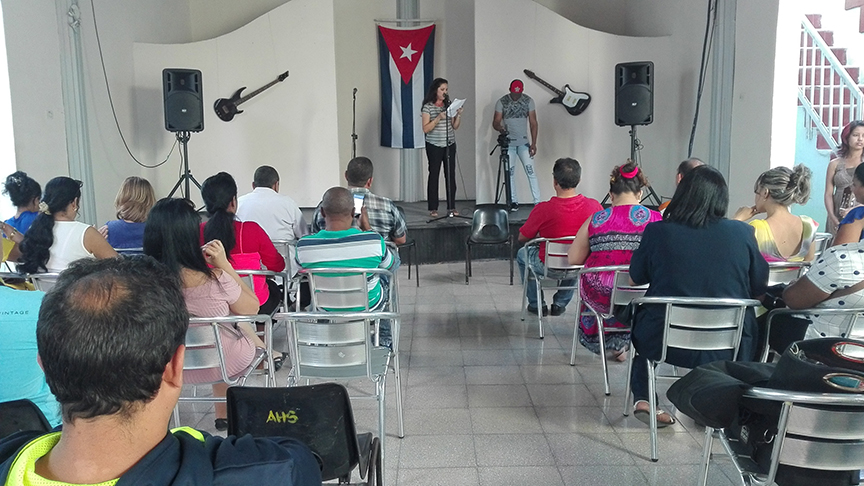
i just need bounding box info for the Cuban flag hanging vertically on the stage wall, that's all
[378,25,435,148]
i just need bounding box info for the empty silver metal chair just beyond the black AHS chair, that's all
[276,311,405,481]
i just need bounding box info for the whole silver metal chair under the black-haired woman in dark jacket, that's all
[624,297,761,462]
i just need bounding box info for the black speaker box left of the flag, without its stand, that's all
[162,68,204,132]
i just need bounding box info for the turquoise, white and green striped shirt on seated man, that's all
[297,228,394,311]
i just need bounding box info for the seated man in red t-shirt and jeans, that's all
[516,158,603,316]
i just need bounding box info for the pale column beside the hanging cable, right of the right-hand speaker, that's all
[708,0,738,180]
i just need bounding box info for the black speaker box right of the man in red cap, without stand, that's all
[615,61,654,127]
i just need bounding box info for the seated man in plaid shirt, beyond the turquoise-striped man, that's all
[312,157,408,264]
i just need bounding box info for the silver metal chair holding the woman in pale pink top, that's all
[174,315,276,426]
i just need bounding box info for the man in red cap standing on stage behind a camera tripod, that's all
[492,79,540,211]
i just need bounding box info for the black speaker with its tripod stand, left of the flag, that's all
[162,68,204,199]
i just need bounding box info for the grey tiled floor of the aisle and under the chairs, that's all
[181,261,737,486]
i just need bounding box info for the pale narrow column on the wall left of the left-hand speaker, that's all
[56,0,97,224]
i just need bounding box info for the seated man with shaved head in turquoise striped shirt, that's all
[297,187,394,347]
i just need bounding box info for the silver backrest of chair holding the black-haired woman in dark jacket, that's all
[633,297,760,362]
